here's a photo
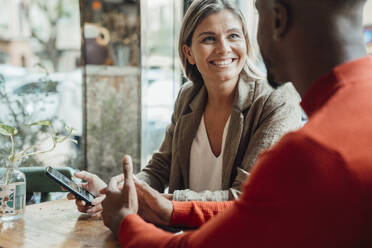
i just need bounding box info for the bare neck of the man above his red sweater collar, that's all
[286,2,367,96]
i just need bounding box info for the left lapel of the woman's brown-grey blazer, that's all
[176,86,207,188]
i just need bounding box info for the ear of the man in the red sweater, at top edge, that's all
[273,1,290,40]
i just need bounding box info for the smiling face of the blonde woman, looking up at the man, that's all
[183,10,247,83]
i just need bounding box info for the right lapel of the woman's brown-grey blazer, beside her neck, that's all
[222,79,255,190]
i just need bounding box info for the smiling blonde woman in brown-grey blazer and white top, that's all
[69,0,301,216]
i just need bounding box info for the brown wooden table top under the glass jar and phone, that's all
[0,200,120,248]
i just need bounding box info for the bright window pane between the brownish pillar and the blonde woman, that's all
[141,0,183,167]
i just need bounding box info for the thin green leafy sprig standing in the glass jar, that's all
[0,120,77,184]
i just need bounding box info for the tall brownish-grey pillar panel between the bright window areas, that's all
[80,0,141,181]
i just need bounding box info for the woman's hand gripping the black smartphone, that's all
[67,171,107,218]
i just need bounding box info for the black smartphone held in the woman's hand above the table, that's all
[45,166,95,205]
